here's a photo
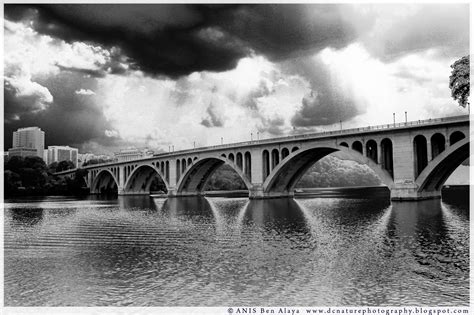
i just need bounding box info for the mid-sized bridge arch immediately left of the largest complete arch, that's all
[176,156,252,195]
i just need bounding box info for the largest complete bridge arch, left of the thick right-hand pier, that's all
[263,146,394,194]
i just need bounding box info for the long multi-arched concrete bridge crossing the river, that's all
[56,115,470,200]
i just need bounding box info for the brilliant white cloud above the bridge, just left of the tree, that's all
[316,44,467,127]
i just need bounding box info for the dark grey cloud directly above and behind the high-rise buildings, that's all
[4,71,117,148]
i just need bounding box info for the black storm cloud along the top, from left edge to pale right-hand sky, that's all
[5,4,355,77]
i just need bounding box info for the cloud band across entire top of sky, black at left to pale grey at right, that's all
[5,4,469,78]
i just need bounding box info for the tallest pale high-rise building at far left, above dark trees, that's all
[8,127,44,158]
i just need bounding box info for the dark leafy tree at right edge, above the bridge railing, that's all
[449,56,469,107]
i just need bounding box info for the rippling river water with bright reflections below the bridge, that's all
[4,192,469,306]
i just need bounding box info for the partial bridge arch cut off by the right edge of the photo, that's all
[416,138,470,192]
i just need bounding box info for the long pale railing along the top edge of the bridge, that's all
[61,115,469,175]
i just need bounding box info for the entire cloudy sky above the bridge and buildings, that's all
[4,3,469,154]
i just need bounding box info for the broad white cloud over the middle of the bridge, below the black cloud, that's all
[96,56,308,150]
